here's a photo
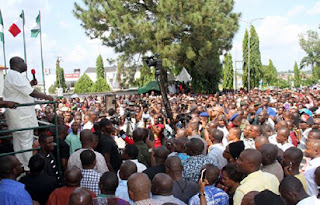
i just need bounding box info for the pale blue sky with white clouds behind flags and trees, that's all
[0,0,320,80]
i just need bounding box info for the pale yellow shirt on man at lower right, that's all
[233,170,279,205]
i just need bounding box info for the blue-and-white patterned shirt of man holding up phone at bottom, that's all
[189,185,229,205]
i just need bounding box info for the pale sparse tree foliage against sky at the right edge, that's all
[299,30,320,71]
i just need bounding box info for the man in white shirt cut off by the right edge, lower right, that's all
[304,139,320,196]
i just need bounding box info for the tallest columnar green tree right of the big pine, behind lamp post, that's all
[242,26,262,88]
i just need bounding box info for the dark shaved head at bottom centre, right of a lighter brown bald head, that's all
[151,173,173,196]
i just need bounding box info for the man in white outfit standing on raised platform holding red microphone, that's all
[3,57,53,170]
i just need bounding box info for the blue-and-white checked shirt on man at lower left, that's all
[80,169,102,195]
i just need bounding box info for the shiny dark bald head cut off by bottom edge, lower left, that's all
[68,187,92,205]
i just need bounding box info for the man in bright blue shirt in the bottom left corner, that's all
[0,156,33,205]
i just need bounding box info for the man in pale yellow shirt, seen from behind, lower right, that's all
[233,149,279,205]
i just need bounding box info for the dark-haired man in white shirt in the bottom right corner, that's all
[279,176,320,205]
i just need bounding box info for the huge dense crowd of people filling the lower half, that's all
[0,56,320,205]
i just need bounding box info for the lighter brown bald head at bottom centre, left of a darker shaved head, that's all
[128,173,151,201]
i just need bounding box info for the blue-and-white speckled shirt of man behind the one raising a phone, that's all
[182,154,218,182]
